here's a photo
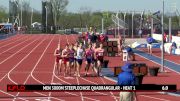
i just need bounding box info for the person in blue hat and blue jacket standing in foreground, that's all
[117,63,136,101]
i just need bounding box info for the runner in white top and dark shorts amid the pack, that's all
[76,43,84,77]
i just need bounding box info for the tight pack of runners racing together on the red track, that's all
[54,41,104,77]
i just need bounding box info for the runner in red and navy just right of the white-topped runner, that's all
[85,44,95,76]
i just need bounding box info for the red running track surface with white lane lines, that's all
[0,35,179,101]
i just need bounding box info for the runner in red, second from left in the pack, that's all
[62,44,69,76]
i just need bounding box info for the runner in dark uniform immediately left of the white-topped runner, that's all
[69,44,75,75]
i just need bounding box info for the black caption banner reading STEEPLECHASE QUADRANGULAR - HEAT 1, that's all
[7,84,176,92]
